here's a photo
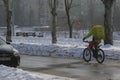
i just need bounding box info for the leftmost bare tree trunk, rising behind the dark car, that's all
[3,0,12,42]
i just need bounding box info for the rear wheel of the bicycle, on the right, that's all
[96,49,105,64]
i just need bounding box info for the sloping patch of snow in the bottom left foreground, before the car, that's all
[0,65,74,80]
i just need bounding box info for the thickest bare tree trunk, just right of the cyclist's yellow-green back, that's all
[101,0,115,45]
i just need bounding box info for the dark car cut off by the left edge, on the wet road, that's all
[0,37,20,67]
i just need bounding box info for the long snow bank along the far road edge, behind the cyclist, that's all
[12,37,120,59]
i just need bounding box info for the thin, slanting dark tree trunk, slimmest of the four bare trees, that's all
[64,0,73,38]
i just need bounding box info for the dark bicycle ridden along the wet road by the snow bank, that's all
[83,41,105,64]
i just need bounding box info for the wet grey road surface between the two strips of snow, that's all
[18,55,120,80]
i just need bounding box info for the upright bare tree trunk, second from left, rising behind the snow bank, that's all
[48,0,57,44]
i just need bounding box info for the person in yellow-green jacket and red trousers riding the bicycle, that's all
[83,25,105,57]
